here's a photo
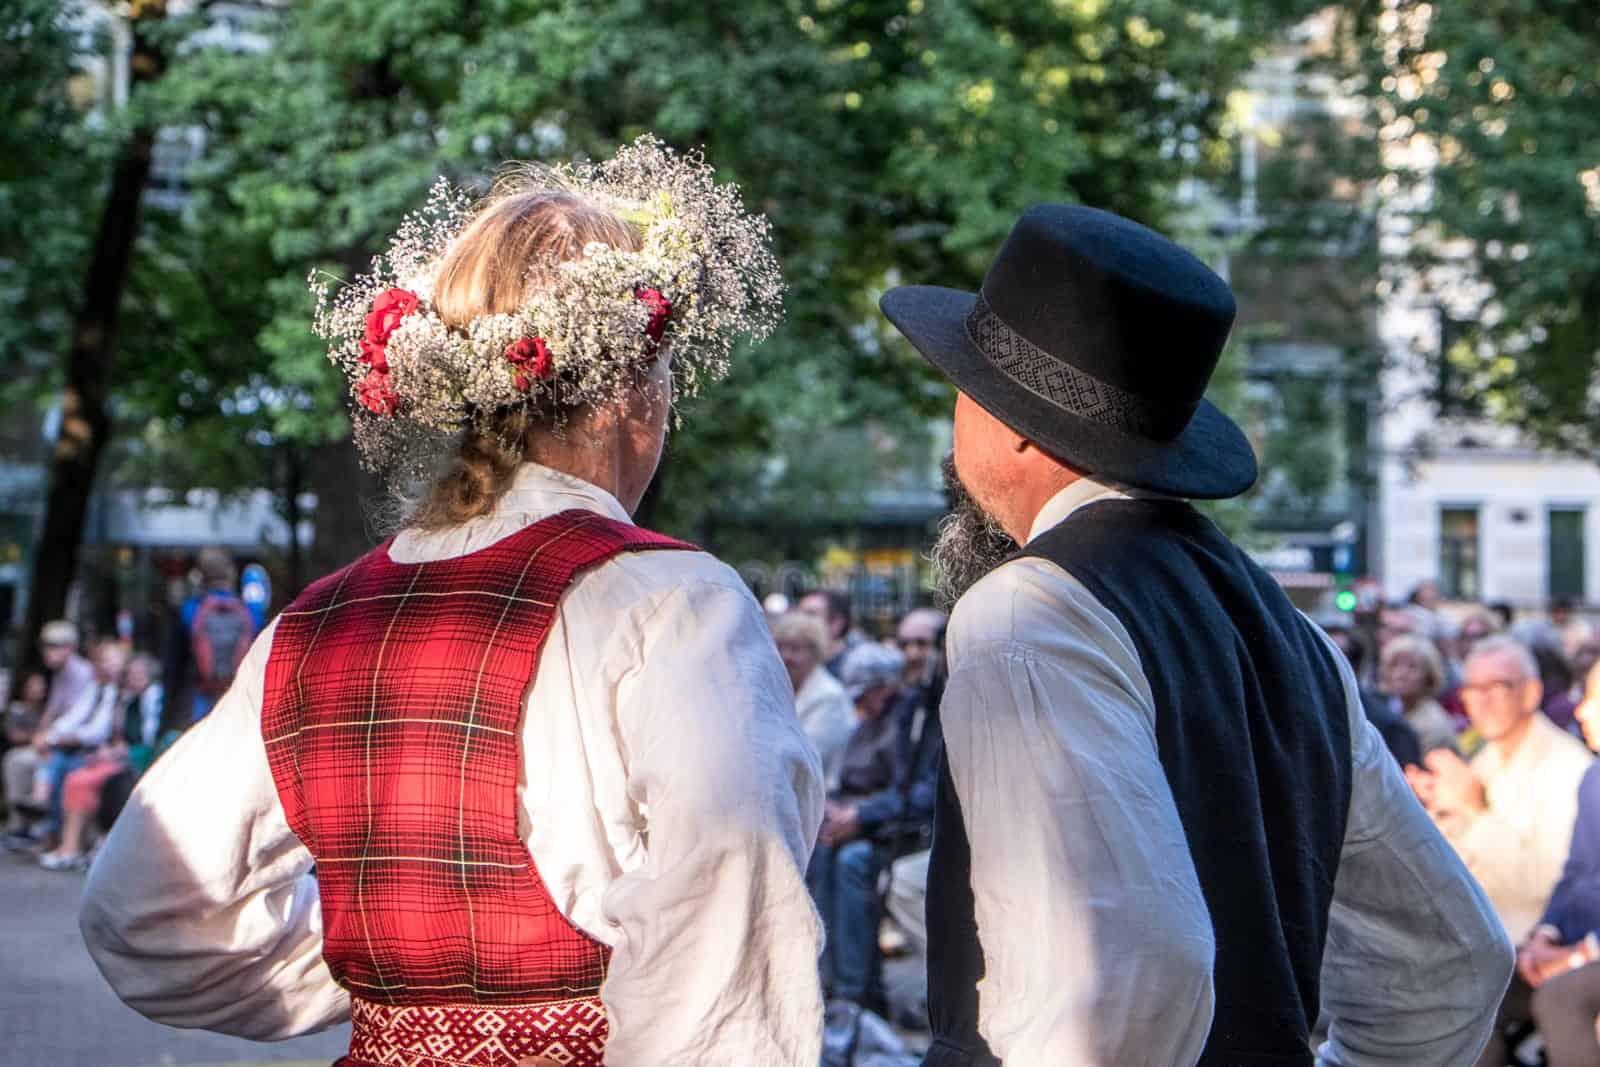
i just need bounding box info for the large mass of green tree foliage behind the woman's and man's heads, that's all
[15,0,1314,591]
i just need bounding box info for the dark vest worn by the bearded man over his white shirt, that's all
[923,501,1350,1067]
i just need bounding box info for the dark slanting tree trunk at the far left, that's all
[18,0,165,664]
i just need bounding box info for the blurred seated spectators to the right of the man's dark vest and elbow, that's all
[1320,582,1600,1067]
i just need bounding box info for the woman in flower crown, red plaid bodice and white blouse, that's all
[82,138,822,1067]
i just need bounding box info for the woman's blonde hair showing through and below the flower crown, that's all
[408,188,642,530]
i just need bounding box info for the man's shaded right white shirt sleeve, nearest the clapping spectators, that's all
[1317,633,1514,1067]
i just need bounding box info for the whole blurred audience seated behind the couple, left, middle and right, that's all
[18,550,1600,1067]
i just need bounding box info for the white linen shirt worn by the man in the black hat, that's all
[930,480,1510,1067]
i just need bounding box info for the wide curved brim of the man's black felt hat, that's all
[878,285,1256,501]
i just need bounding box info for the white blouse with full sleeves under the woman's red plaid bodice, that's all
[82,464,822,1067]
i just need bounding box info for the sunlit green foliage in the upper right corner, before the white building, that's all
[1347,0,1600,453]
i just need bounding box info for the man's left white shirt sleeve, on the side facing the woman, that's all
[941,560,1216,1067]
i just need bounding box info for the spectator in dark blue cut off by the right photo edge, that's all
[1480,665,1600,1067]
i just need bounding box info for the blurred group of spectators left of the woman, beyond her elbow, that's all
[0,549,262,870]
